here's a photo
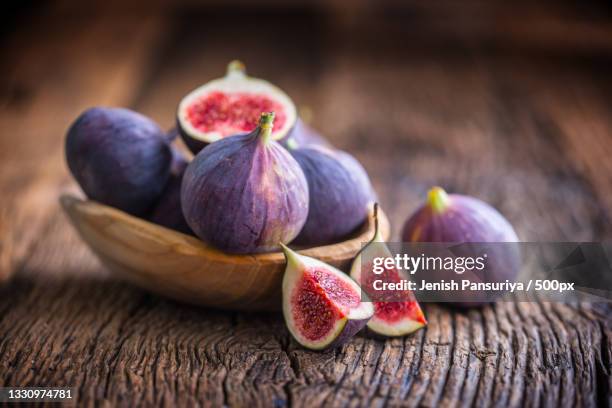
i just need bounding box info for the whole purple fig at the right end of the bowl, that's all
[290,146,372,246]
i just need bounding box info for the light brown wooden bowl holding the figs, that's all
[60,195,390,310]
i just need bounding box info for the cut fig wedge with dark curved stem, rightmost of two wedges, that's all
[351,204,427,336]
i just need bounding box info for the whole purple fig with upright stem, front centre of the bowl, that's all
[181,112,308,254]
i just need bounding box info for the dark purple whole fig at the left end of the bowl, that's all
[65,107,172,216]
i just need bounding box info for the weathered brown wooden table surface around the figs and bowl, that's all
[0,5,612,406]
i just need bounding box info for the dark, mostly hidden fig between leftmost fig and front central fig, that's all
[148,146,194,235]
